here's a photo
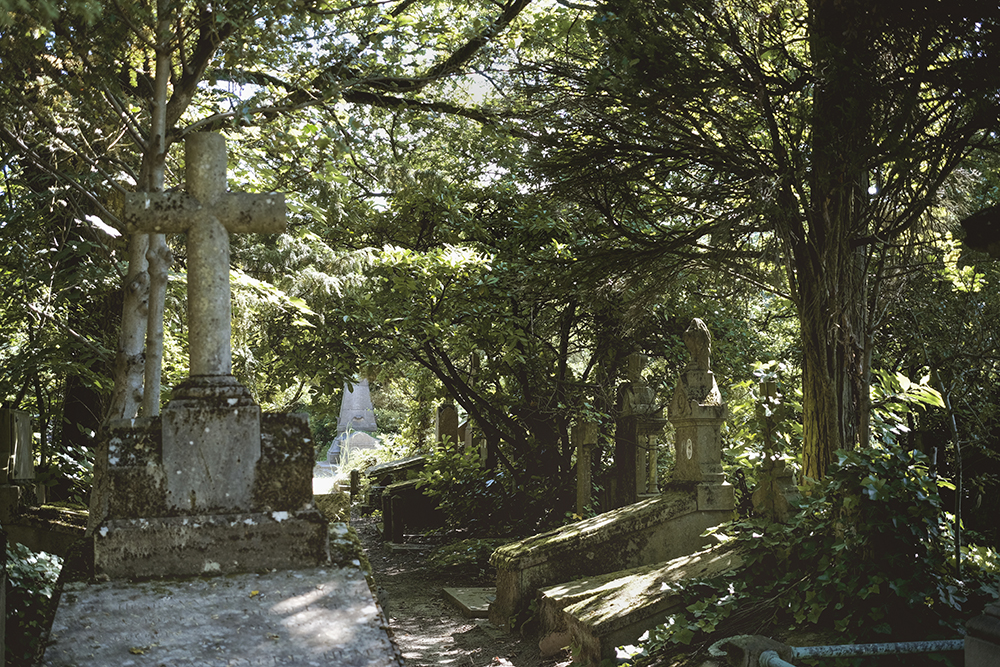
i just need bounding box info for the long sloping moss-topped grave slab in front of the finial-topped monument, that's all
[490,485,732,627]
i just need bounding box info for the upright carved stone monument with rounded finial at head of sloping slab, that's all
[667,318,735,509]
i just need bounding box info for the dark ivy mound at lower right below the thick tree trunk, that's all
[647,448,998,664]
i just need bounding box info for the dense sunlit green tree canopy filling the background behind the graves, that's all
[0,0,1000,544]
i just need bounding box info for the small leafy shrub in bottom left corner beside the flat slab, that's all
[6,542,62,665]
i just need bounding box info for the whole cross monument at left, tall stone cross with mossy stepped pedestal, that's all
[88,134,328,578]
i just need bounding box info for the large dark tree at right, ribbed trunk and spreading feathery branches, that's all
[523,0,1000,479]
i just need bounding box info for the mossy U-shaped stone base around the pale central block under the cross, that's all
[88,411,327,578]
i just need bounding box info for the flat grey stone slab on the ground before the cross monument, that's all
[42,567,403,667]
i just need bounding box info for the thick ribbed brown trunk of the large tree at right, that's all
[792,0,877,480]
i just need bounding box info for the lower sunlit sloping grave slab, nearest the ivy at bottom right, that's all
[539,545,743,665]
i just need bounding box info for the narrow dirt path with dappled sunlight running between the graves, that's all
[351,518,571,667]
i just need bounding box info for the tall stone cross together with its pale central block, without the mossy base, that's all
[125,133,285,514]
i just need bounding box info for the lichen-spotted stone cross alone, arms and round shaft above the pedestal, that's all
[124,133,285,377]
